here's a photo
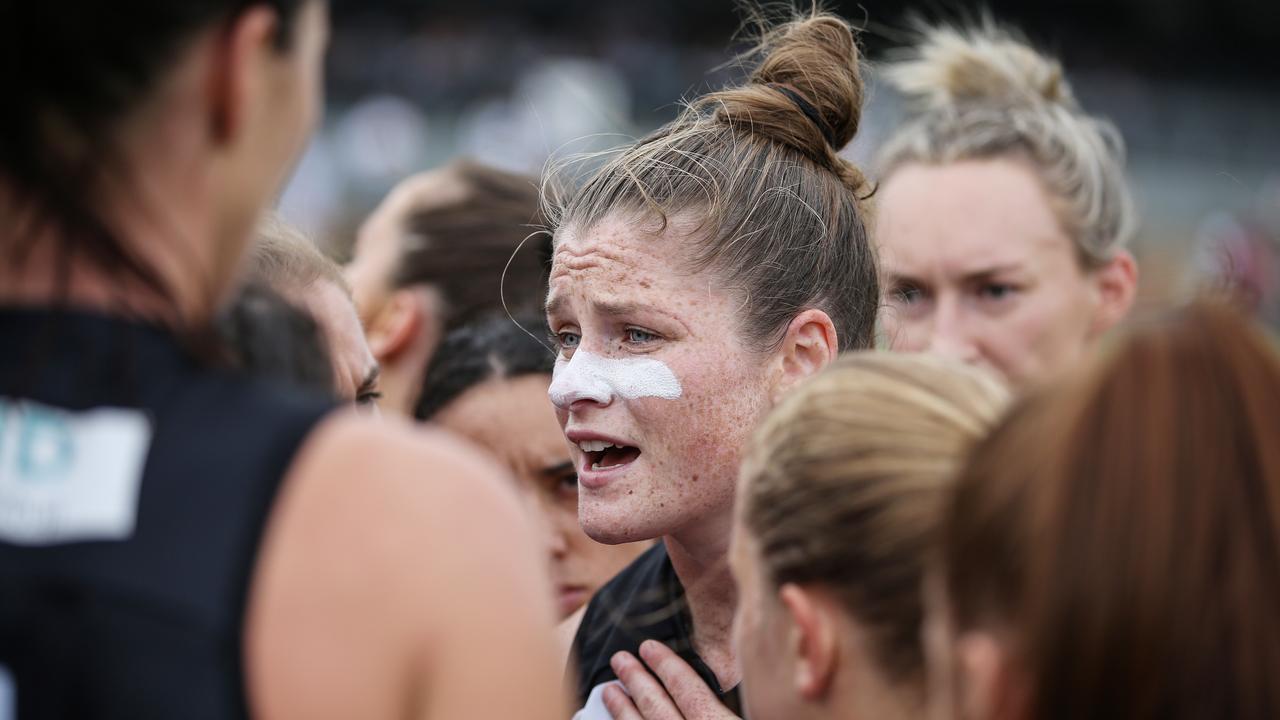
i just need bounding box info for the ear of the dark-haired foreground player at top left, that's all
[206,4,279,145]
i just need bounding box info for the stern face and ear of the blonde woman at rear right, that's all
[877,158,1137,387]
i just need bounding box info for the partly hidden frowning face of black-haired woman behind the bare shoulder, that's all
[433,375,648,619]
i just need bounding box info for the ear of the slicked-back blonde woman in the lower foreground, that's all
[778,583,838,701]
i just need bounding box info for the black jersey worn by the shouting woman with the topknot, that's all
[570,542,742,715]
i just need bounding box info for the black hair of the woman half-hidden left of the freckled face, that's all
[413,315,556,420]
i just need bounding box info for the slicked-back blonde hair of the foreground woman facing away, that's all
[740,352,1009,687]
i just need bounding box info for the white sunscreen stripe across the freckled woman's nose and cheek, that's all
[547,350,684,410]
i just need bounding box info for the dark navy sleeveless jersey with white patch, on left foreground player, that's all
[0,309,333,720]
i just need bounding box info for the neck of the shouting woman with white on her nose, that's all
[663,510,741,689]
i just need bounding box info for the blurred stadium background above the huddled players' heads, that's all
[282,0,1280,319]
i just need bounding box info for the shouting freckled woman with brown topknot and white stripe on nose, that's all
[547,13,879,717]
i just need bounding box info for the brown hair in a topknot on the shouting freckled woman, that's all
[548,6,879,348]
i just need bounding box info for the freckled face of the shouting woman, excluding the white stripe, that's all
[548,215,768,543]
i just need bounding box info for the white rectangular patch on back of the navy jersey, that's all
[0,397,152,544]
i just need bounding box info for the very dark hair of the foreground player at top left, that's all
[0,0,305,311]
